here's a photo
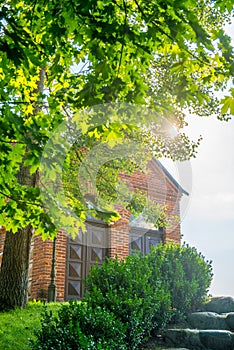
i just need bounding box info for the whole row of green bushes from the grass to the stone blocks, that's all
[33,244,212,350]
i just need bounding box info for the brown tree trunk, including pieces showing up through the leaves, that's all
[0,67,45,310]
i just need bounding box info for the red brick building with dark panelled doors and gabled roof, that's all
[0,160,188,301]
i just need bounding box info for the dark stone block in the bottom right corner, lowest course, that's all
[200,330,233,350]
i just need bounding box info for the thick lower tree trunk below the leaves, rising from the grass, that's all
[0,226,33,310]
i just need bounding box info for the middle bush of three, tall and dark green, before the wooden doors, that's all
[85,254,170,349]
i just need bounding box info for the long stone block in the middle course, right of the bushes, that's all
[188,312,229,330]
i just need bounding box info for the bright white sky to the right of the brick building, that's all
[163,23,234,296]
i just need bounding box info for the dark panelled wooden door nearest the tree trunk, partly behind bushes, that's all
[65,223,108,300]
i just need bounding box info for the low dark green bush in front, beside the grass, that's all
[32,302,127,350]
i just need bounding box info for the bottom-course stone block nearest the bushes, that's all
[165,329,203,349]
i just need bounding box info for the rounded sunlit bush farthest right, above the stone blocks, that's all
[147,244,213,315]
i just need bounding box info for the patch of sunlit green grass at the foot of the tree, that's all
[0,302,61,350]
